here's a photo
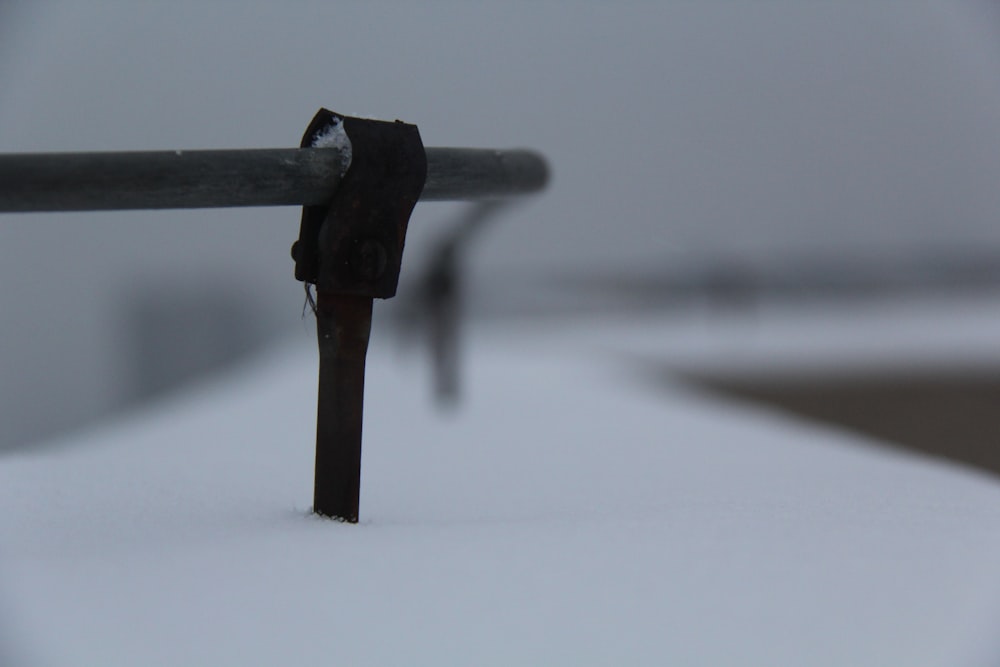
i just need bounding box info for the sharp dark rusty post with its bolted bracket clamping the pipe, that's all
[292,109,427,523]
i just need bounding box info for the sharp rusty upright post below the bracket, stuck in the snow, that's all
[313,291,372,523]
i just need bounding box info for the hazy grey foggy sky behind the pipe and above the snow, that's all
[0,0,1000,449]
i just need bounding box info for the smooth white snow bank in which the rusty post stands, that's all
[0,313,1000,667]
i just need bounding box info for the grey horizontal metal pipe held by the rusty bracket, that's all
[0,148,548,213]
